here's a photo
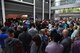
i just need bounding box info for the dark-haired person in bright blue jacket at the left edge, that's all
[0,27,8,50]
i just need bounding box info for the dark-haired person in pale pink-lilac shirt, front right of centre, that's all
[45,29,63,53]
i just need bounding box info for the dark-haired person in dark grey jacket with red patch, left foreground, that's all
[3,28,24,53]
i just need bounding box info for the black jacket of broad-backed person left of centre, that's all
[18,32,32,50]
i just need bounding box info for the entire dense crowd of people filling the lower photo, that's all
[0,18,80,53]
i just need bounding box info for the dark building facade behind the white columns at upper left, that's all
[0,0,52,22]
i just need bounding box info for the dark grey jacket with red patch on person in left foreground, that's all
[4,39,23,53]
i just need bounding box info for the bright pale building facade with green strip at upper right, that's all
[51,0,80,18]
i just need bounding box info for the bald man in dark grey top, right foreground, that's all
[61,29,71,53]
